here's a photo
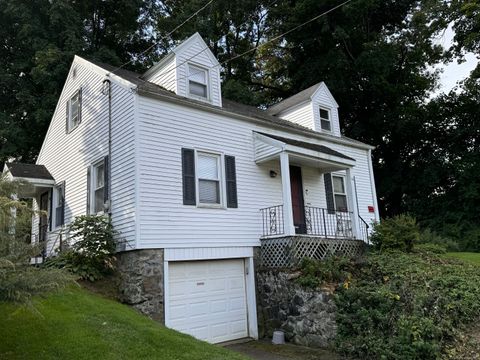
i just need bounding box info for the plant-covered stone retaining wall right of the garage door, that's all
[256,269,337,347]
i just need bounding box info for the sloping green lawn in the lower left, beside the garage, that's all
[0,287,246,360]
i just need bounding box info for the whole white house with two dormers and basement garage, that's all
[5,34,379,342]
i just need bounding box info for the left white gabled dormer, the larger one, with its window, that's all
[142,33,222,107]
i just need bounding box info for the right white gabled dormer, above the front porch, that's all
[268,82,340,136]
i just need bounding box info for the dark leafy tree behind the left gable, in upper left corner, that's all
[0,0,156,162]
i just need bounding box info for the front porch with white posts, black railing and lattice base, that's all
[255,133,369,267]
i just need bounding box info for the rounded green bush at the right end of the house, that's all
[371,215,420,252]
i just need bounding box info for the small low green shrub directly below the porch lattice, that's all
[297,256,353,288]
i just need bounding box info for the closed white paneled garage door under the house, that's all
[168,259,248,343]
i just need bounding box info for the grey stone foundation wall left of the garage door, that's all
[117,249,165,323]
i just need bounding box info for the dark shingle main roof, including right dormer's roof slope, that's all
[88,60,376,146]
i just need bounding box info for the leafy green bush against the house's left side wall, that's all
[45,215,116,282]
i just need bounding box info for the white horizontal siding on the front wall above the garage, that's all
[138,96,378,248]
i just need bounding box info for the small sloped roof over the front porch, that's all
[254,132,355,172]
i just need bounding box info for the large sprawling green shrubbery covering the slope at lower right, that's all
[336,252,480,360]
